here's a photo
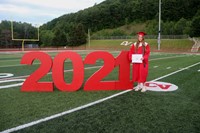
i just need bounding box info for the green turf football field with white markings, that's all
[0,50,200,133]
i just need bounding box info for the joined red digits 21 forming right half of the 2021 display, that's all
[84,51,133,91]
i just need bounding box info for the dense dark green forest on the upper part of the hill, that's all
[43,0,200,31]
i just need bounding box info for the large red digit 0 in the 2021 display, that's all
[52,52,84,91]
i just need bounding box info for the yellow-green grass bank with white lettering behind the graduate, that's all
[87,39,193,52]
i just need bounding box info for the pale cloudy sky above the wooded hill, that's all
[0,0,105,26]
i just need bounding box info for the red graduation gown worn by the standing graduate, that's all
[129,42,150,83]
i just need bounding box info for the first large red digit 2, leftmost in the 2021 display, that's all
[21,52,53,92]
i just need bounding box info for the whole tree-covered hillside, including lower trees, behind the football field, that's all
[0,0,200,46]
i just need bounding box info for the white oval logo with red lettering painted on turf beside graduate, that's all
[145,81,178,92]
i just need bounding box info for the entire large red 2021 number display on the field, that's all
[21,51,133,92]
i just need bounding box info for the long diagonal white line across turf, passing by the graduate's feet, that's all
[1,62,200,133]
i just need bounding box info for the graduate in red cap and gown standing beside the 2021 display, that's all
[129,32,150,92]
